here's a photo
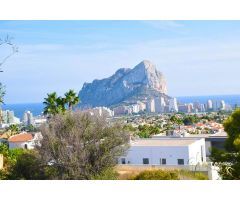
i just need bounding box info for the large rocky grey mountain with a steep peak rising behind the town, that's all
[79,60,169,107]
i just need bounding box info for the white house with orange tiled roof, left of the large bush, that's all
[8,132,42,149]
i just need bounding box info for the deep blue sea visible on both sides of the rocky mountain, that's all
[2,95,240,119]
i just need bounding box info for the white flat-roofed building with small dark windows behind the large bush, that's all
[118,138,206,166]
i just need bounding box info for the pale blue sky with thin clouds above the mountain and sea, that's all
[0,21,240,103]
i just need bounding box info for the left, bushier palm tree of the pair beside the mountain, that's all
[43,92,65,115]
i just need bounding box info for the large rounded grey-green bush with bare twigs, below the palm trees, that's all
[38,112,129,180]
